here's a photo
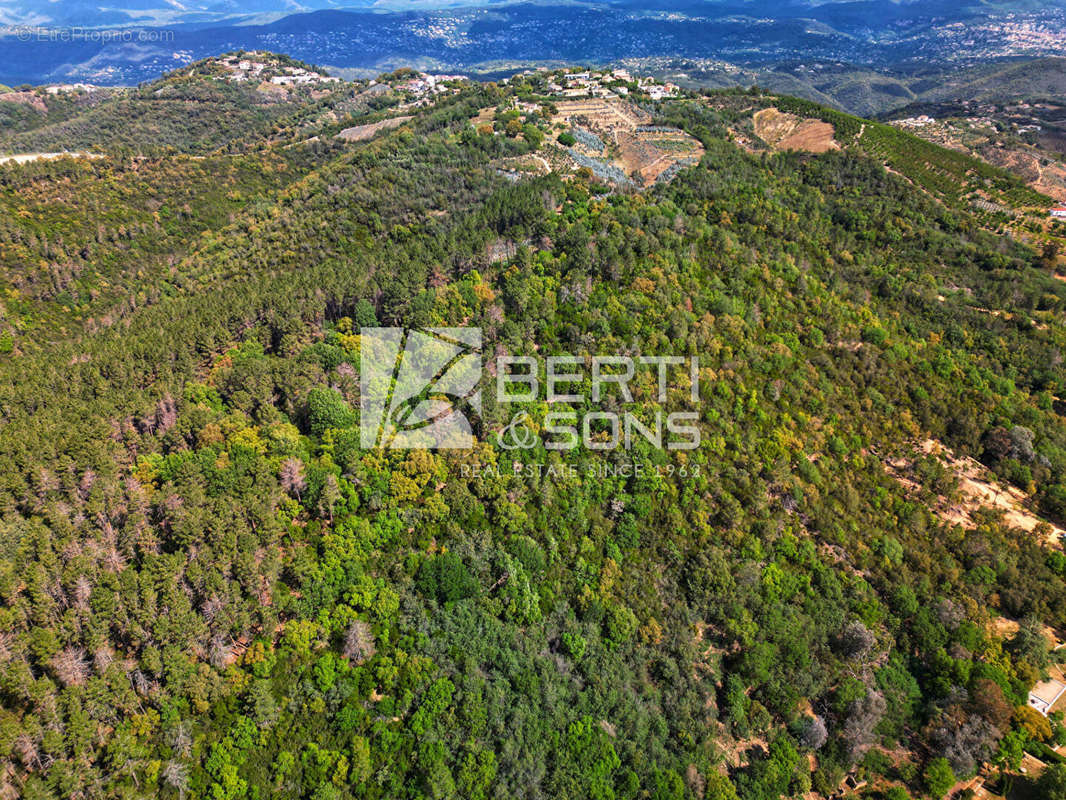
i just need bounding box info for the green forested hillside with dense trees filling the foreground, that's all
[0,57,1066,800]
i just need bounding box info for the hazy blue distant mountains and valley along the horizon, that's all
[0,0,1066,93]
